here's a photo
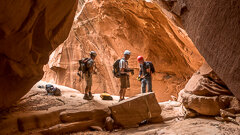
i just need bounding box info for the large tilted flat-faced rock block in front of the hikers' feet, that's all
[109,93,161,128]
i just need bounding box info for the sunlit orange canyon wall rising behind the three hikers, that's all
[43,0,203,101]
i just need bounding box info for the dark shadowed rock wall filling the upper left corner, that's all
[0,0,77,108]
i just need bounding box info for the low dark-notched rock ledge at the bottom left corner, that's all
[0,109,63,135]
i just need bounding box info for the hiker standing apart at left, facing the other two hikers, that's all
[83,51,97,100]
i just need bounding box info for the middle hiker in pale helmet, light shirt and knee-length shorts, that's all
[119,50,134,101]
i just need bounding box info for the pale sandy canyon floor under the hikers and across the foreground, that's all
[0,81,240,135]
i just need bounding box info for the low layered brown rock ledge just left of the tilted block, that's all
[40,108,110,134]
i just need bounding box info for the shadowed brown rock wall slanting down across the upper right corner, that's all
[172,0,240,99]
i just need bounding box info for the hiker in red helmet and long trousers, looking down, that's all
[137,56,152,93]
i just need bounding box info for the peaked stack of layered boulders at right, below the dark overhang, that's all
[178,63,233,116]
